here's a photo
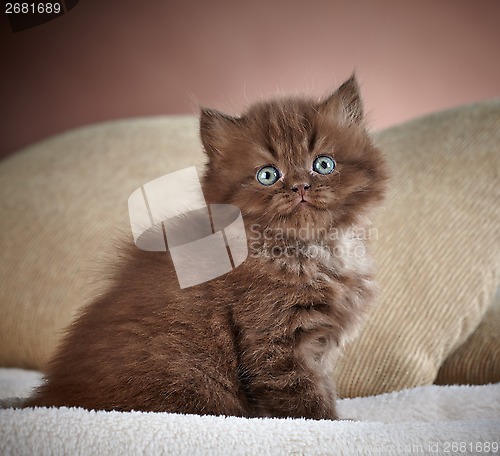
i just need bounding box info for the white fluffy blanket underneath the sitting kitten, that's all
[0,369,500,456]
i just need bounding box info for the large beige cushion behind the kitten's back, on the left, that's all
[0,117,203,368]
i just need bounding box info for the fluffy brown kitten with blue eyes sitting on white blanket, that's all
[26,77,386,419]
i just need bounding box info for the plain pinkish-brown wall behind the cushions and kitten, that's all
[0,0,500,156]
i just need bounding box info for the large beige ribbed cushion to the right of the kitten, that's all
[338,101,500,396]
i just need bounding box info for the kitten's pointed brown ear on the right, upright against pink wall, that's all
[319,74,363,125]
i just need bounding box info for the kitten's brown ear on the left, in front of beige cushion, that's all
[200,108,241,161]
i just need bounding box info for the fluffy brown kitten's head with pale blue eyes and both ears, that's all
[200,77,387,239]
